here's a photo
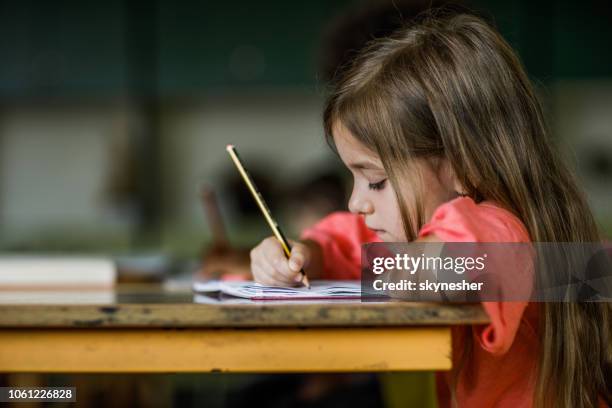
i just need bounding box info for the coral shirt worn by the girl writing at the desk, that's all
[302,197,539,408]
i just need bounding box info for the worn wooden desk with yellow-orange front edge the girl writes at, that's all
[0,286,488,373]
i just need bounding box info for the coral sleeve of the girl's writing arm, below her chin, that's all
[300,212,380,279]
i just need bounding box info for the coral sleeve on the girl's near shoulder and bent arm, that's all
[419,197,530,355]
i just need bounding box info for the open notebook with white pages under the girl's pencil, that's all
[193,280,361,300]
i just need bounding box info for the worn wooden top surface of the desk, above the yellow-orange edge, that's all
[0,285,488,328]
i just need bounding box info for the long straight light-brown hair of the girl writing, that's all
[324,11,612,408]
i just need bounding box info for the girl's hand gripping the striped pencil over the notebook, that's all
[250,237,311,286]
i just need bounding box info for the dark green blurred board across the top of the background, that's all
[0,0,612,100]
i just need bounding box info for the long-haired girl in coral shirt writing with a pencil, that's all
[251,14,612,407]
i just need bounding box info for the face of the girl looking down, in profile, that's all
[333,122,462,242]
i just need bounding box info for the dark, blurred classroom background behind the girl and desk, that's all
[0,0,612,406]
